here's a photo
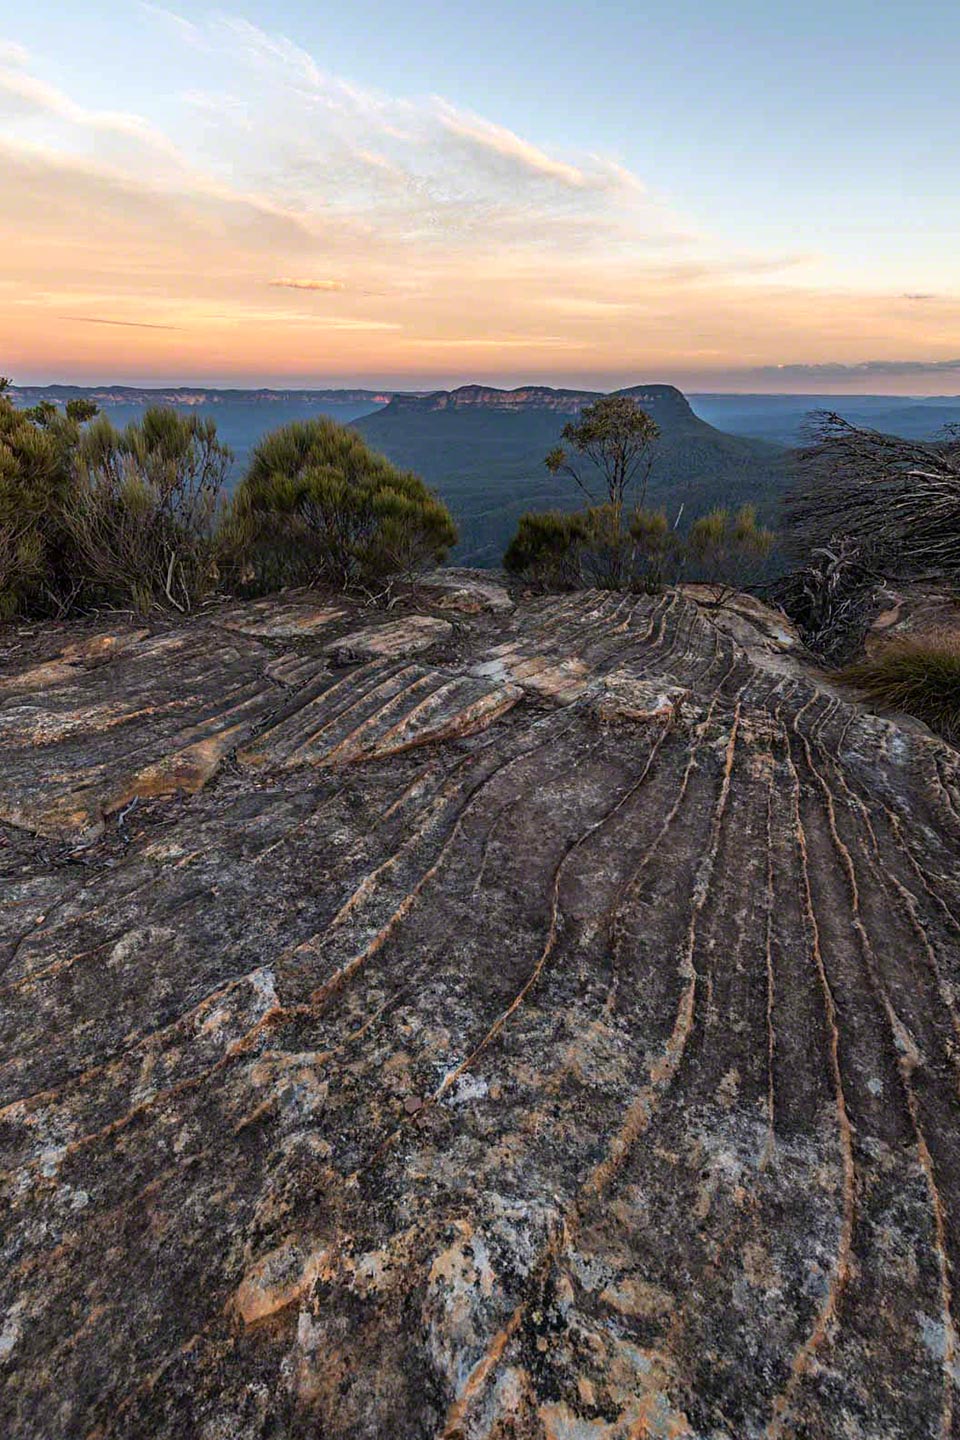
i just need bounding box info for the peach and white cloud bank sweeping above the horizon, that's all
[0,4,960,387]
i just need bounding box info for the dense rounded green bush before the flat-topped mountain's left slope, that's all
[230,418,456,593]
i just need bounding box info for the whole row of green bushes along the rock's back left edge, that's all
[0,382,456,618]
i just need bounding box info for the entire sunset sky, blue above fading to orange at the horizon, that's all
[0,0,960,395]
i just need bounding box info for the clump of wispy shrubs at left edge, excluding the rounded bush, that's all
[0,387,230,618]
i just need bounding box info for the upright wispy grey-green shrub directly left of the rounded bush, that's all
[63,408,232,611]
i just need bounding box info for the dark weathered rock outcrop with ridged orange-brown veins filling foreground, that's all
[0,593,960,1440]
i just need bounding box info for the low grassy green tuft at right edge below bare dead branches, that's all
[839,632,960,742]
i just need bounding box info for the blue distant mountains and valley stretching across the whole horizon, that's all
[13,384,960,566]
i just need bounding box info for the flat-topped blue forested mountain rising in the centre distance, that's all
[354,384,787,566]
